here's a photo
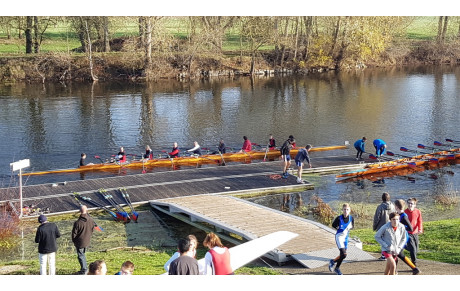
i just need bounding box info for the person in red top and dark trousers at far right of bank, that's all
[404,198,423,265]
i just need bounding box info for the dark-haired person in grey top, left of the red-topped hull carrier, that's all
[168,238,200,275]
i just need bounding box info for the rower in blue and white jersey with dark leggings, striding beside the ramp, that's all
[329,203,355,275]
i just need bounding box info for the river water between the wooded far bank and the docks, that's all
[0,66,460,218]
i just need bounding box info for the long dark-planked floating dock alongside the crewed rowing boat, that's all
[0,156,363,214]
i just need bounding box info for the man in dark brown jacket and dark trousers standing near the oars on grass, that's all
[72,205,96,275]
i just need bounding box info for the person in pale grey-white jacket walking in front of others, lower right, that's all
[375,212,407,275]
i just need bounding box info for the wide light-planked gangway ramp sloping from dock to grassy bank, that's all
[149,194,375,268]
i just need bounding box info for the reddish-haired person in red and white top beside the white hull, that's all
[203,232,233,275]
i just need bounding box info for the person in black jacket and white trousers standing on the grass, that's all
[35,214,61,275]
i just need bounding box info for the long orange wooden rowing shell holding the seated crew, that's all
[22,145,347,176]
